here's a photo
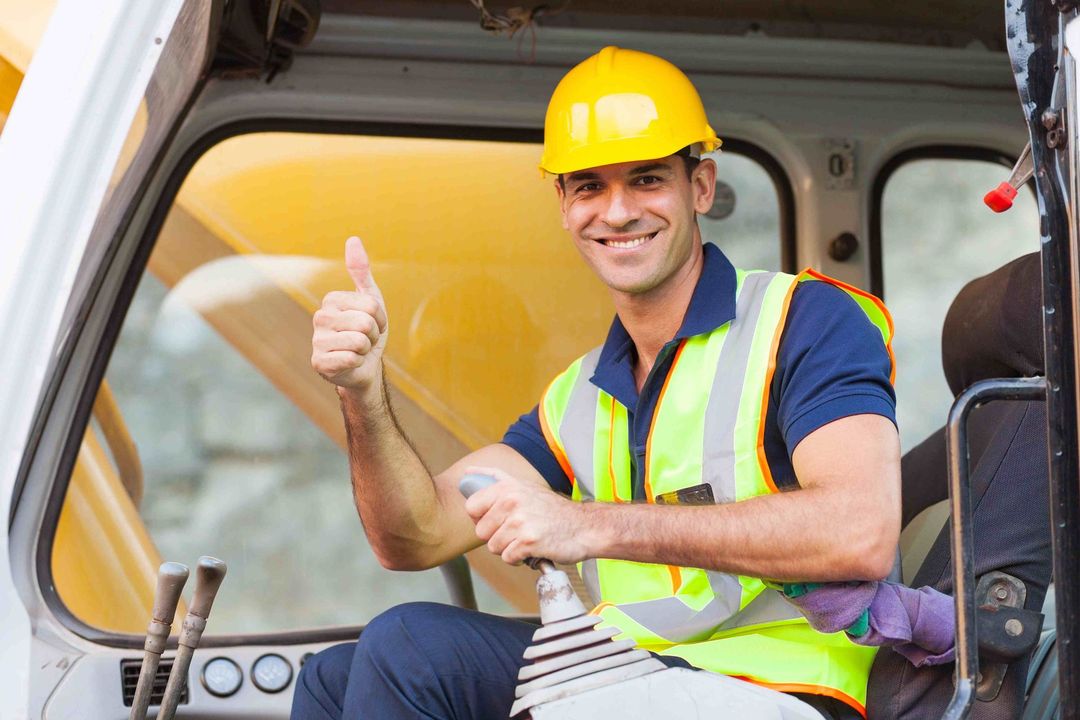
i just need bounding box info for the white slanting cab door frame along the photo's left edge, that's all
[0,0,214,718]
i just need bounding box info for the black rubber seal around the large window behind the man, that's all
[35,118,796,651]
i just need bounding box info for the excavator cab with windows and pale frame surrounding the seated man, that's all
[0,0,1080,720]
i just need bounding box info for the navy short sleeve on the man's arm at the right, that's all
[770,281,896,457]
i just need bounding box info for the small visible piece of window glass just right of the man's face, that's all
[699,152,782,270]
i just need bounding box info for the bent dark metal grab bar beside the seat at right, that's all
[943,378,1047,720]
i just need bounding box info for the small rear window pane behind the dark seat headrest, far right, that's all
[881,160,1039,450]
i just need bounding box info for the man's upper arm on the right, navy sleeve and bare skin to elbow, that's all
[772,283,901,573]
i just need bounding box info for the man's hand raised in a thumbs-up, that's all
[311,237,387,390]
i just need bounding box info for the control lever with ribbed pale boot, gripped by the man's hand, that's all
[458,474,665,718]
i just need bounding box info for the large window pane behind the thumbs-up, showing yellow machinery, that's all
[54,133,779,634]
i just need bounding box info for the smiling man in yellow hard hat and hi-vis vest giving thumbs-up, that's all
[294,47,900,718]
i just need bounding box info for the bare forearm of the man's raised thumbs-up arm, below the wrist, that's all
[338,381,446,569]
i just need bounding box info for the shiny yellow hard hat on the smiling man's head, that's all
[540,46,720,175]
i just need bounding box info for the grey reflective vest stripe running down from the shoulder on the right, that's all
[701,272,777,503]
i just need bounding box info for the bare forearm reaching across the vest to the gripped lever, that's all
[583,488,900,581]
